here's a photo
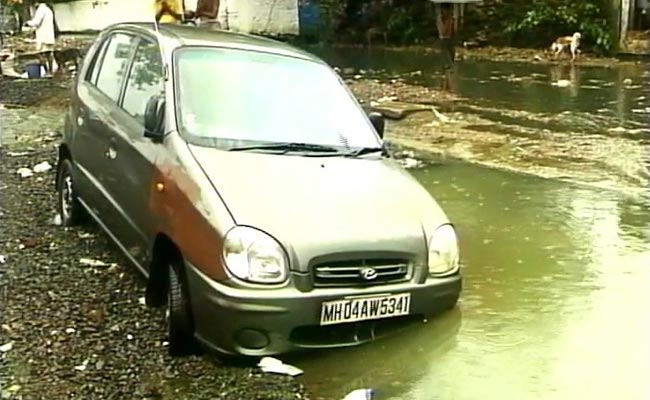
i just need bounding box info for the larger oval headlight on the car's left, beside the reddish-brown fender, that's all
[223,226,288,283]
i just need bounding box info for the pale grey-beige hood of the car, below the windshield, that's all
[190,145,448,271]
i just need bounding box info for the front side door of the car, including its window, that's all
[106,36,165,266]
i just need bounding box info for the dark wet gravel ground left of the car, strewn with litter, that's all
[0,80,309,400]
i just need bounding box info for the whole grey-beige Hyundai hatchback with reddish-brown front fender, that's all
[57,24,461,356]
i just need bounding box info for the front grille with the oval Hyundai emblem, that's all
[314,259,409,287]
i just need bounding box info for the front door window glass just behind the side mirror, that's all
[122,40,164,124]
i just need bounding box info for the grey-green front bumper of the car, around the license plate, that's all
[186,264,462,356]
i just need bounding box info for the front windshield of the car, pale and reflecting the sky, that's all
[175,47,381,152]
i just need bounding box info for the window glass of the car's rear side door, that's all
[95,33,134,102]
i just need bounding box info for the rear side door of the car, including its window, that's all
[72,32,135,222]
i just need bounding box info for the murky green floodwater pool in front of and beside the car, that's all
[295,164,650,400]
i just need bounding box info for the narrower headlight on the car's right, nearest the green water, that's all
[429,224,459,275]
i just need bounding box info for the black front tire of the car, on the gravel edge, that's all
[167,261,198,357]
